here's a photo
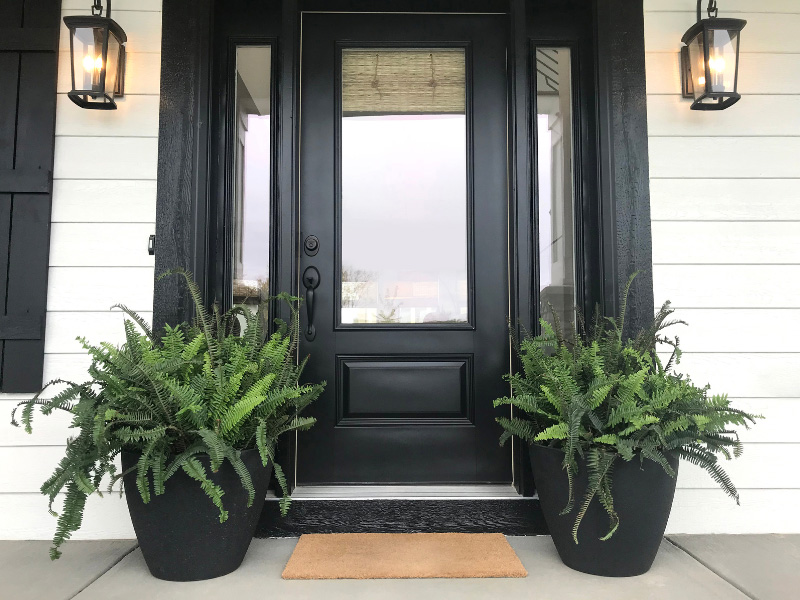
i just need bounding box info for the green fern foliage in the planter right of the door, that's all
[494,275,761,544]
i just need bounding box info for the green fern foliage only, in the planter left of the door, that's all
[11,270,325,559]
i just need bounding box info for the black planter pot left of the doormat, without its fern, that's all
[122,450,272,581]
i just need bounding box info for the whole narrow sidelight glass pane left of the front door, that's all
[233,46,272,304]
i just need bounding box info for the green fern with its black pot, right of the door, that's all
[495,275,760,577]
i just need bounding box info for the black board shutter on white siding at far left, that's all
[0,0,61,393]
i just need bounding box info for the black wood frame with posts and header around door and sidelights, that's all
[154,0,654,516]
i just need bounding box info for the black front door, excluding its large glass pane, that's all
[297,11,513,485]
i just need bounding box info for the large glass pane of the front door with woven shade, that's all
[341,49,469,324]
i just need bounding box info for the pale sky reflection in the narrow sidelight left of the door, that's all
[242,115,271,281]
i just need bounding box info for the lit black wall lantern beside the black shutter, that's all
[64,0,128,110]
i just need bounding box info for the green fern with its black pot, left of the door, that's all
[12,271,324,581]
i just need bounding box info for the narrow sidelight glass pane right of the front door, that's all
[536,48,575,323]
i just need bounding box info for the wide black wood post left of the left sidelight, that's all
[152,0,214,331]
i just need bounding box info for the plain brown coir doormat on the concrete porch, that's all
[283,533,528,579]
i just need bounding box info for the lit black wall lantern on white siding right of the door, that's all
[681,0,747,110]
